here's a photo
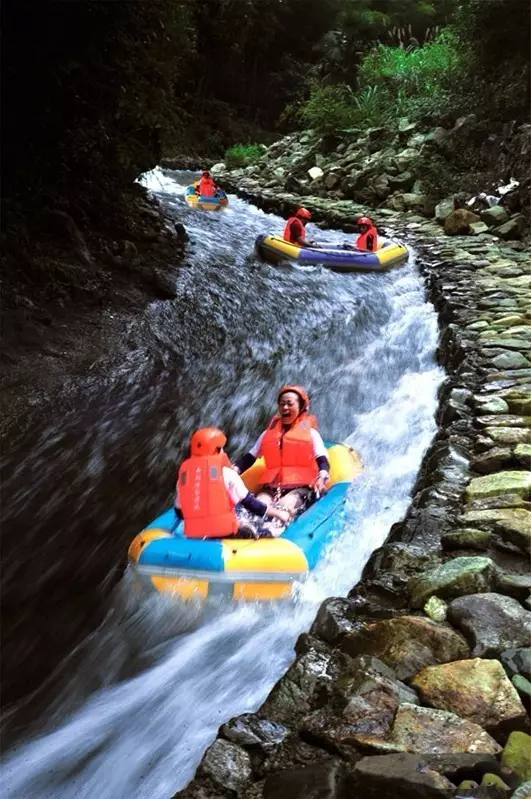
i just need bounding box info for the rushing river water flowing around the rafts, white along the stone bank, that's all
[0,170,442,799]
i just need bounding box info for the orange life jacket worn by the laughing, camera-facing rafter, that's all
[261,413,319,488]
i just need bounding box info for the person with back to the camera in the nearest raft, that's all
[174,427,290,538]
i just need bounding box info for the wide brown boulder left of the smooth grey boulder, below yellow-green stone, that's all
[340,616,469,680]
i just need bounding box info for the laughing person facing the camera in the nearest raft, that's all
[235,386,330,528]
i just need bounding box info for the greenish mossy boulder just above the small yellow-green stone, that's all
[408,556,496,608]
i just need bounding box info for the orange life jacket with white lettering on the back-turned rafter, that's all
[177,453,238,538]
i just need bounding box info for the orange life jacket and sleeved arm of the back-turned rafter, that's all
[175,454,267,538]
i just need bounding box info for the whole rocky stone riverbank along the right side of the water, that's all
[175,134,531,799]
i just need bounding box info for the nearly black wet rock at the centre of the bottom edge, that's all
[263,759,345,799]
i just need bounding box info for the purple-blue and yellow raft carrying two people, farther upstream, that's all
[255,236,409,272]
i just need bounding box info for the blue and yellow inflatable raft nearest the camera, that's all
[129,444,362,600]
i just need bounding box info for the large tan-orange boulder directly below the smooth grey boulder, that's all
[411,658,527,738]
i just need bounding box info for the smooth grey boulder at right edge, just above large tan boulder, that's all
[448,593,531,657]
